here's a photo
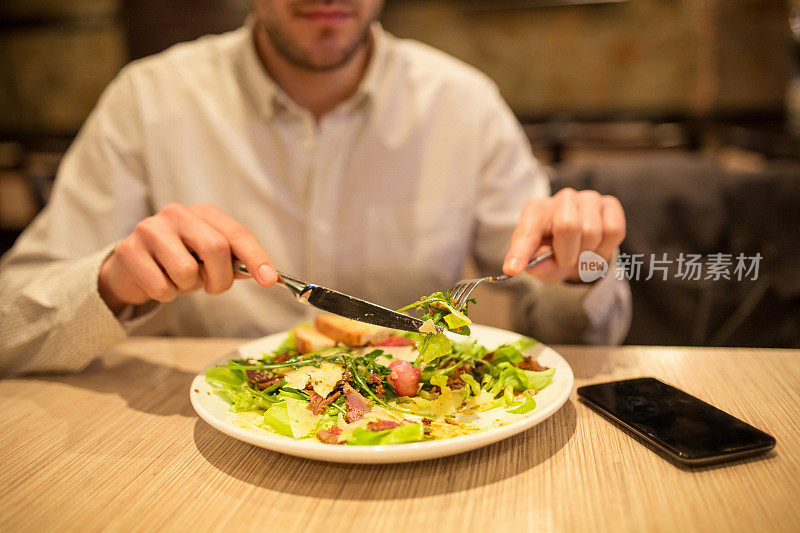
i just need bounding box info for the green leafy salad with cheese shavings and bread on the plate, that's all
[206,292,555,445]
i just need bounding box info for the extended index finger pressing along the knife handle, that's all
[192,204,278,287]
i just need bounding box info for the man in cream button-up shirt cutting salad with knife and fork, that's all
[0,0,630,373]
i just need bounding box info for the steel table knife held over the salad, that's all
[234,261,443,333]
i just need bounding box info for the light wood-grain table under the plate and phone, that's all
[0,338,800,533]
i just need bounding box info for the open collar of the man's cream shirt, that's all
[240,13,388,120]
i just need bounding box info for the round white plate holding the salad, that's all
[189,325,574,463]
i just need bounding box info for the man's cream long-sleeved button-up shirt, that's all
[0,20,630,372]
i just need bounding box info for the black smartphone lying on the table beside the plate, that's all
[578,378,775,465]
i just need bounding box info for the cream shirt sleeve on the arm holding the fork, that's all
[473,86,631,344]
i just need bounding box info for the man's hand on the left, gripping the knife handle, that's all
[97,203,278,313]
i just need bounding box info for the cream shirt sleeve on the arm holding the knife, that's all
[0,66,149,374]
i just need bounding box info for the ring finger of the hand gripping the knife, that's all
[136,217,200,294]
